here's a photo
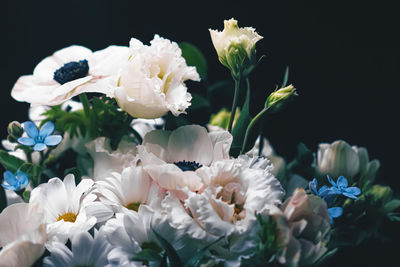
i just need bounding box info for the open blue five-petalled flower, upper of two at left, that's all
[17,121,62,151]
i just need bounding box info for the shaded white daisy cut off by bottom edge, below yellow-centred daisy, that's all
[43,228,112,267]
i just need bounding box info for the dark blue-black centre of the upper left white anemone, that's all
[53,59,89,84]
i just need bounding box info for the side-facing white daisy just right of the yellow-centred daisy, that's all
[95,166,164,215]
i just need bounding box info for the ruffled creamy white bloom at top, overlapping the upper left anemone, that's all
[114,35,200,119]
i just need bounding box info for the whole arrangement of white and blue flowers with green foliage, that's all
[0,19,400,266]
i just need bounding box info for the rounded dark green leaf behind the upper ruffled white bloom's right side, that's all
[179,42,207,80]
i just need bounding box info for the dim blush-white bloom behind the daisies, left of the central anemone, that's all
[86,137,137,181]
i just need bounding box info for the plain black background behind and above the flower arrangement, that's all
[0,0,400,263]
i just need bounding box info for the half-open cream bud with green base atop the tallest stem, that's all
[209,18,263,75]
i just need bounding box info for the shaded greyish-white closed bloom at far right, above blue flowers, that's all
[317,140,380,183]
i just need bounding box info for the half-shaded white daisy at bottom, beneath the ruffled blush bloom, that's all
[104,205,200,266]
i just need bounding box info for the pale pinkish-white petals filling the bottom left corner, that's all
[0,203,47,266]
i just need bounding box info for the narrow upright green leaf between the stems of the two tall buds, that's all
[230,87,252,157]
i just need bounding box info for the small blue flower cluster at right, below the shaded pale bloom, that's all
[308,176,361,224]
